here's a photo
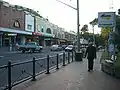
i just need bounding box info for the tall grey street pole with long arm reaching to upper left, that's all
[56,0,80,52]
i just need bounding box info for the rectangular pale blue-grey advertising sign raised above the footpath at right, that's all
[98,12,116,27]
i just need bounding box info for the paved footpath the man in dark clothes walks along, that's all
[13,52,120,90]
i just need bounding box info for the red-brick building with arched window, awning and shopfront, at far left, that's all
[0,2,32,46]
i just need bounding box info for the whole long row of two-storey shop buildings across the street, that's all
[0,1,74,46]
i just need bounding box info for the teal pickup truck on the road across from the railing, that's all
[18,42,43,53]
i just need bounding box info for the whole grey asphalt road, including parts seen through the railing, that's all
[0,47,71,90]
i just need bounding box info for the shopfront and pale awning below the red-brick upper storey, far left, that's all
[0,27,32,46]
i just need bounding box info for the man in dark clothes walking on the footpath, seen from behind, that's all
[85,42,96,72]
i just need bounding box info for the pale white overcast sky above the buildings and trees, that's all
[4,0,120,33]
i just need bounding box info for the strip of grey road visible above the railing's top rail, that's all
[0,47,63,66]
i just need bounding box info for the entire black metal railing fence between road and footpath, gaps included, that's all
[0,52,74,90]
